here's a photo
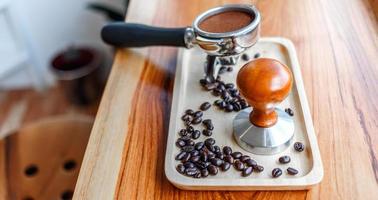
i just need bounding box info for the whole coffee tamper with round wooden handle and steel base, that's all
[233,58,294,155]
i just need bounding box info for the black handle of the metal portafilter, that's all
[101,22,186,47]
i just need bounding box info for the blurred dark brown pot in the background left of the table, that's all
[51,47,104,106]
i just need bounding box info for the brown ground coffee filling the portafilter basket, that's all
[199,11,254,33]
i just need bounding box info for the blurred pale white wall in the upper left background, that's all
[0,0,123,88]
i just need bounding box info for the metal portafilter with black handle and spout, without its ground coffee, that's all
[101,4,261,78]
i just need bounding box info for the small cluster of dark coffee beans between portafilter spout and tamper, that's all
[200,76,249,112]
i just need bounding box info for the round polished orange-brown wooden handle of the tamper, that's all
[236,58,293,128]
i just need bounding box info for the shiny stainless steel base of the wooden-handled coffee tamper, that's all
[233,108,294,155]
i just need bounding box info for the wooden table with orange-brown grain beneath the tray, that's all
[75,0,378,199]
